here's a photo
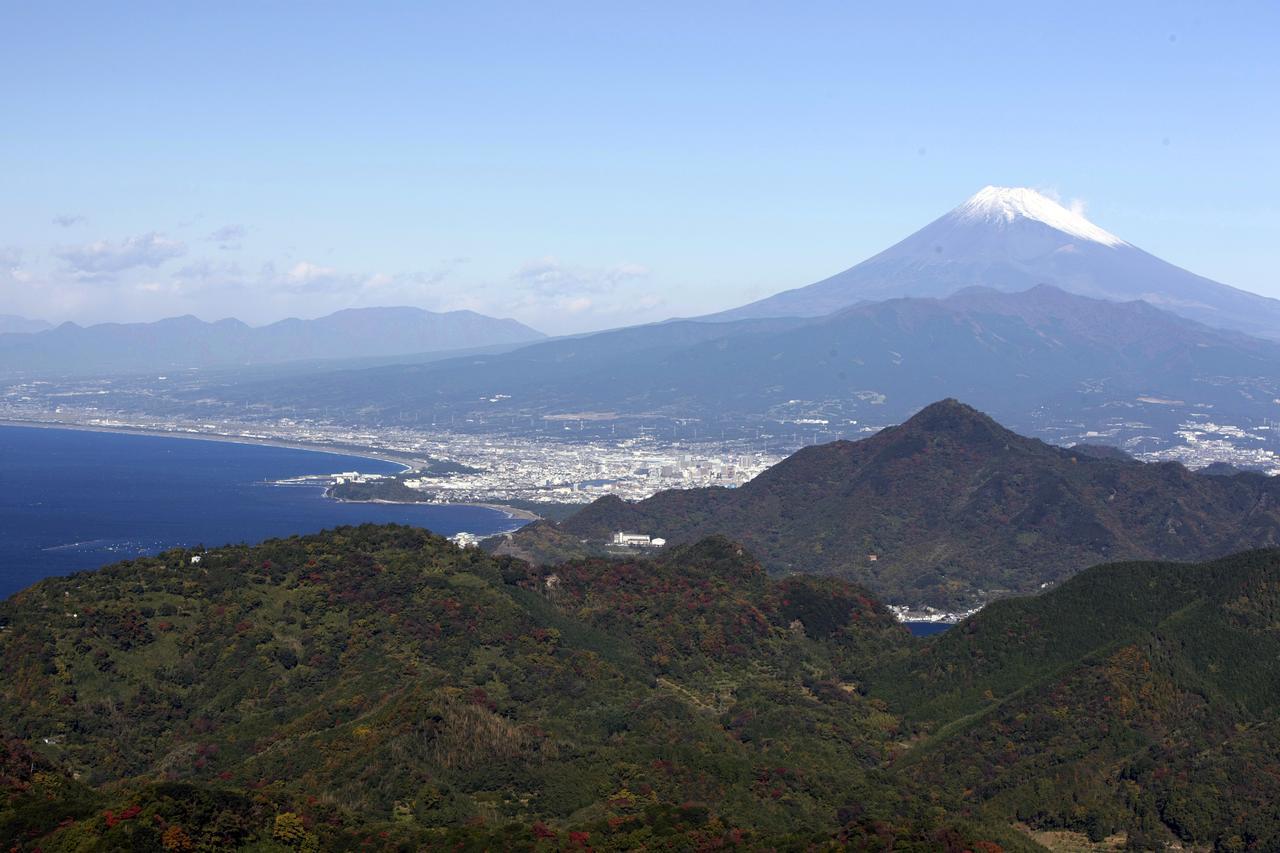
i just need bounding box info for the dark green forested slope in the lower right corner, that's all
[870,549,1280,850]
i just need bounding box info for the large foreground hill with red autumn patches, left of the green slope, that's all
[0,526,1033,852]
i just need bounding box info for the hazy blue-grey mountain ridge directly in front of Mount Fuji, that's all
[193,286,1280,432]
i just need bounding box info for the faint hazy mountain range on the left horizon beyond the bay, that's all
[0,307,545,374]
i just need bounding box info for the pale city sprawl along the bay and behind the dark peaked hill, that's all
[0,378,1280,489]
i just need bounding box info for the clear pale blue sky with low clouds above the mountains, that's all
[0,0,1280,333]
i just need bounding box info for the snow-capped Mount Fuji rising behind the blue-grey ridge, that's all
[704,187,1280,338]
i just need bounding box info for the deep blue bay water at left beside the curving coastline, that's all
[0,427,520,598]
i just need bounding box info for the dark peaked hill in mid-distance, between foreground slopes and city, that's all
[511,400,1280,607]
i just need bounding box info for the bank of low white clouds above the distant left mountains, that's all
[10,234,663,332]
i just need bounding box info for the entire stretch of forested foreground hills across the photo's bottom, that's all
[0,525,1280,853]
